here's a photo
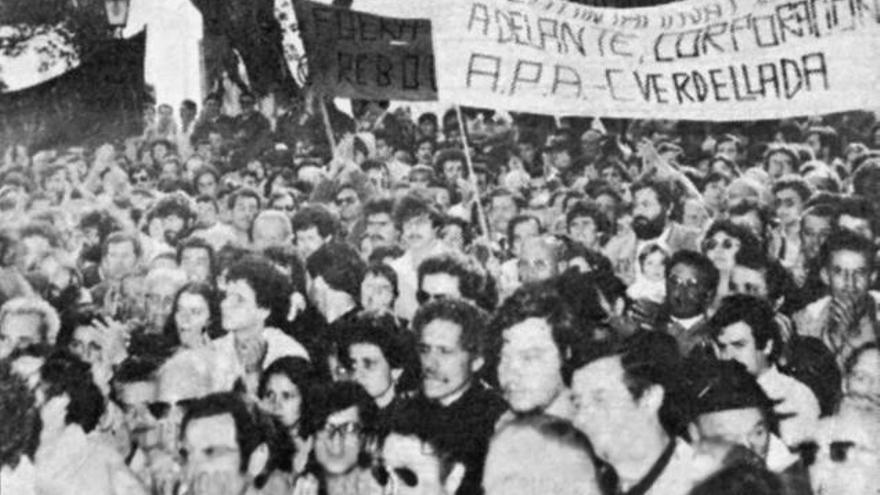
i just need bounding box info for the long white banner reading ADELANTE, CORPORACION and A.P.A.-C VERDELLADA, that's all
[431,0,880,120]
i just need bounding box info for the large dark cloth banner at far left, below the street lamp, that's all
[0,31,147,149]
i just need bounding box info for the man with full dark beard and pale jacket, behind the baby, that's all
[605,180,700,284]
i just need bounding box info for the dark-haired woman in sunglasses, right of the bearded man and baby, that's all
[702,220,761,306]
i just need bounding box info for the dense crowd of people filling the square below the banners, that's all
[0,93,880,495]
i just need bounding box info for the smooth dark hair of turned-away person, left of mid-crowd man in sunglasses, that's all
[306,242,367,300]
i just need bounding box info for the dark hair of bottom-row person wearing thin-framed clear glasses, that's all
[304,381,379,436]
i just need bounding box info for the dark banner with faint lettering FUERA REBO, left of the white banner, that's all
[294,0,437,101]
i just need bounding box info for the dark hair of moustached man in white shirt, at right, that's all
[707,294,782,362]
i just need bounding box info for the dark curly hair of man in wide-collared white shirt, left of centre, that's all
[226,256,292,326]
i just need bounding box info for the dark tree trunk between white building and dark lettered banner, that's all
[191,0,298,96]
